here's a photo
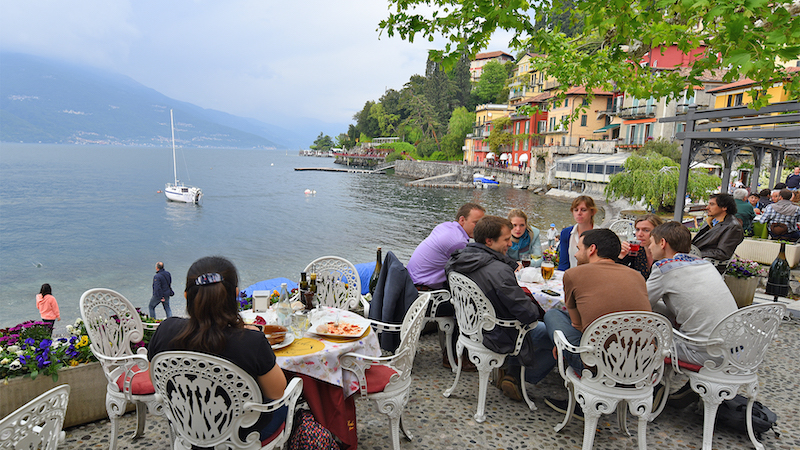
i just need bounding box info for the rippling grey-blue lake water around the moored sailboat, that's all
[0,143,572,328]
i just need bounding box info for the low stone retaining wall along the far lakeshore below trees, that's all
[394,160,530,186]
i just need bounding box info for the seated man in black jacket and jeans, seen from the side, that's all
[445,216,555,400]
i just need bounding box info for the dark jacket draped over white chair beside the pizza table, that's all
[369,252,419,352]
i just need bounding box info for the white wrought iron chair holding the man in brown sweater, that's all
[553,311,672,450]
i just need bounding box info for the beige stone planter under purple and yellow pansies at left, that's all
[0,362,108,428]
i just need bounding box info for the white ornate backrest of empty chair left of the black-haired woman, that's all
[80,289,147,382]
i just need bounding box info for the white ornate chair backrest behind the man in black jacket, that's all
[447,272,497,345]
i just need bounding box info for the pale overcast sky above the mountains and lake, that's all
[0,0,508,131]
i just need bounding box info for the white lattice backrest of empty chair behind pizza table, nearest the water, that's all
[305,256,361,310]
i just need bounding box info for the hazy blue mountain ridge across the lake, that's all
[0,52,341,149]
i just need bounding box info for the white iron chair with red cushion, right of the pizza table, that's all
[339,292,431,450]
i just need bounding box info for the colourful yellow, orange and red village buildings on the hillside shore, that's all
[322,45,800,196]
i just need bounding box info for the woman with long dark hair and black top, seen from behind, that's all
[147,256,286,441]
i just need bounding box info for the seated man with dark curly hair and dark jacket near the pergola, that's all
[692,194,744,273]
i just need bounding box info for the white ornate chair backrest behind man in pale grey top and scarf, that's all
[701,303,786,375]
